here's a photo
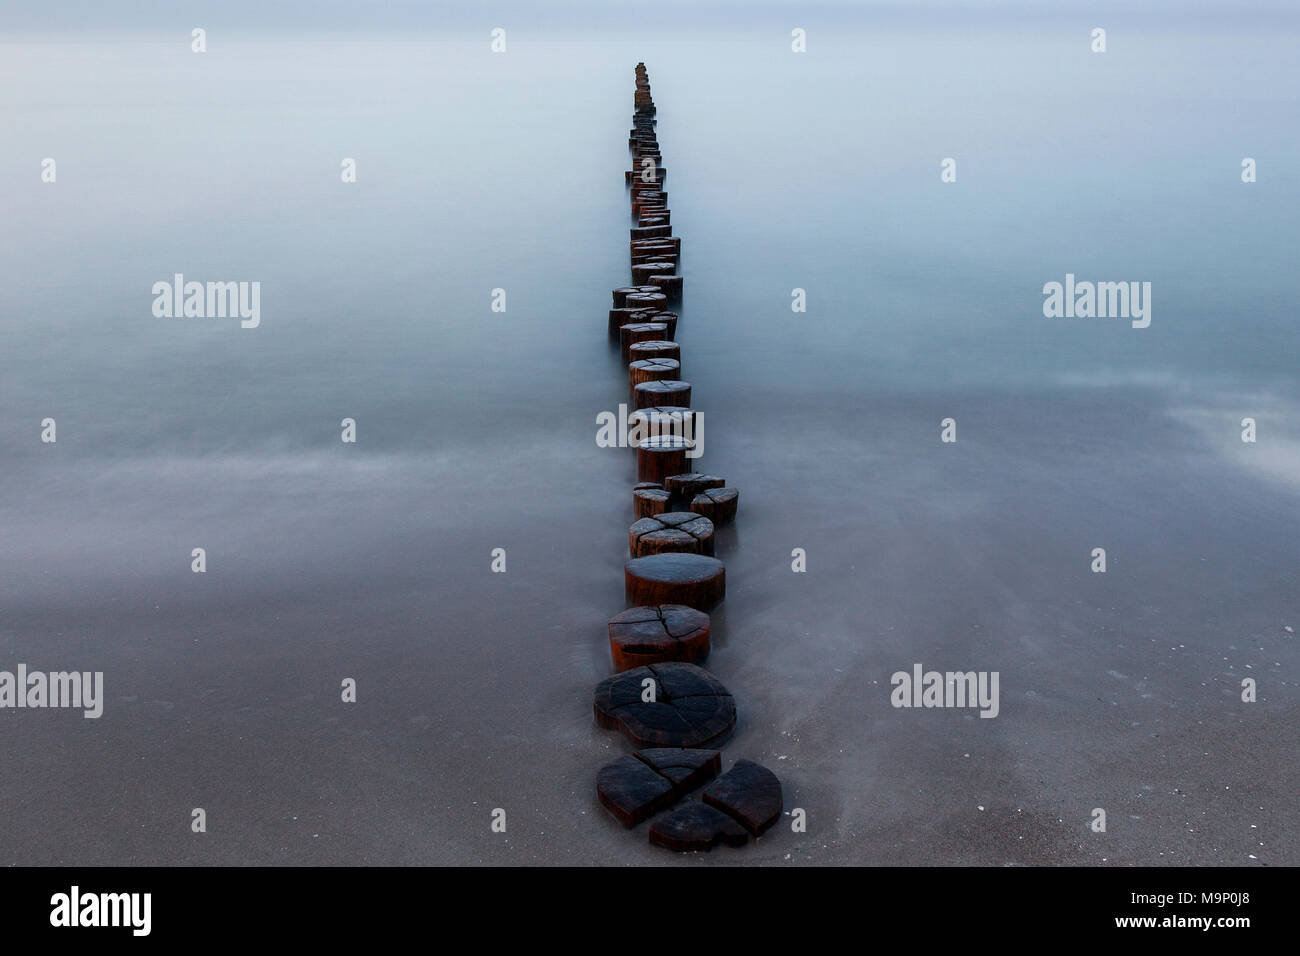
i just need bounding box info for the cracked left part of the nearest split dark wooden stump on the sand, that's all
[595,747,722,827]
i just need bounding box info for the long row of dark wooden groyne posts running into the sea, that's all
[594,64,783,851]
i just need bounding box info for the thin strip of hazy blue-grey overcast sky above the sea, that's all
[0,0,1300,39]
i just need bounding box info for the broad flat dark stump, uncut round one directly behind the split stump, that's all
[594,661,736,747]
